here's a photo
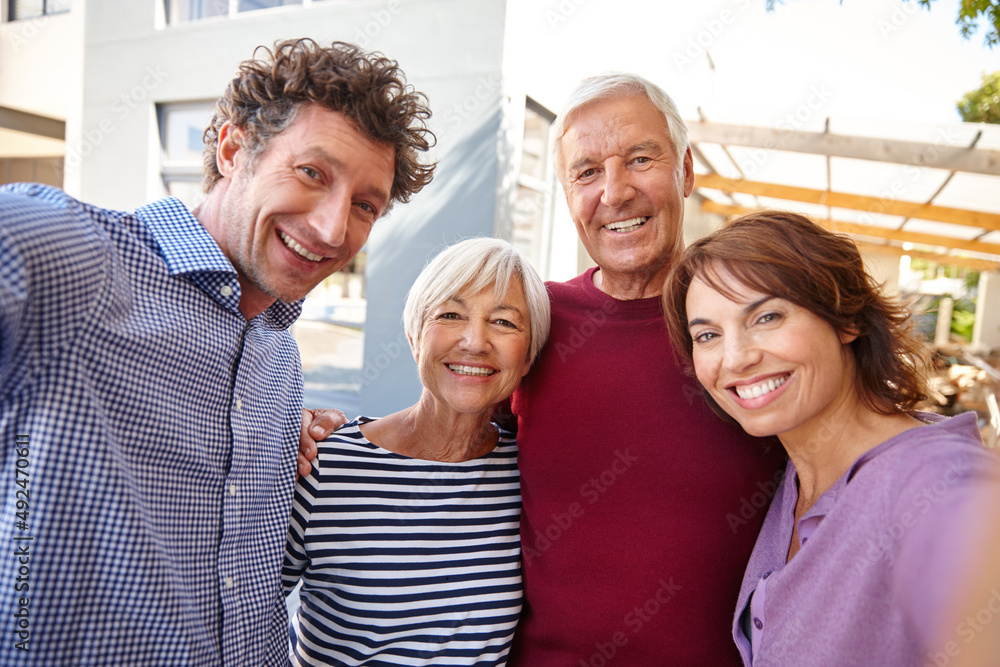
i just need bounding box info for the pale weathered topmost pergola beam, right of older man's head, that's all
[688,121,1000,176]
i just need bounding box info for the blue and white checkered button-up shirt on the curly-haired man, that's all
[0,185,302,667]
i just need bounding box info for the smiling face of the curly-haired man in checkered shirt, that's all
[210,105,395,314]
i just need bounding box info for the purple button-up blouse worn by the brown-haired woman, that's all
[733,413,1000,667]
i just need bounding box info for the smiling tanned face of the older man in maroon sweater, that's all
[560,95,694,282]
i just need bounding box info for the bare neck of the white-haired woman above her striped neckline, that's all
[362,389,497,462]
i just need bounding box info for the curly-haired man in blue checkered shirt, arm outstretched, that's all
[0,40,433,667]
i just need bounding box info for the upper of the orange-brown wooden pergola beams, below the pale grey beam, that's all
[695,174,1000,231]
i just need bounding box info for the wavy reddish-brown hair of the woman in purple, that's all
[663,211,926,414]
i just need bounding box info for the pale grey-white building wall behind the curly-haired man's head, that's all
[77,0,507,415]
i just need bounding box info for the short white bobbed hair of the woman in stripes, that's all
[403,238,551,363]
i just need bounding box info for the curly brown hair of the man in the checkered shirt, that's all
[204,38,434,203]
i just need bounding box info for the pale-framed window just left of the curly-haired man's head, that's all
[156,101,214,208]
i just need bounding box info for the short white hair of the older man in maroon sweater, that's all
[552,72,688,180]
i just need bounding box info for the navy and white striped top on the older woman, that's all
[282,417,521,667]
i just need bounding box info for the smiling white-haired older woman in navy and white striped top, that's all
[282,238,549,665]
